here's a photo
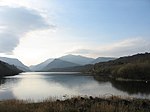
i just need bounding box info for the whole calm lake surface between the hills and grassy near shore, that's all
[0,72,150,101]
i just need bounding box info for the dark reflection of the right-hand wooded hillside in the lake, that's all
[94,76,150,95]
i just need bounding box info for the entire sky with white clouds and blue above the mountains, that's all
[0,0,150,65]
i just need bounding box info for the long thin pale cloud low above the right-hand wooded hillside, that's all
[69,38,150,57]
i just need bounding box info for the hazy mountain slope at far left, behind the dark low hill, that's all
[0,57,30,71]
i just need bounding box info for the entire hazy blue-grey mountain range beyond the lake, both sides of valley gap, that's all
[0,54,115,72]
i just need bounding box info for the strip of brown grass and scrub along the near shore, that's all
[0,96,150,112]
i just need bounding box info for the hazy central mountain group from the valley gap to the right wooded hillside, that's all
[30,54,115,71]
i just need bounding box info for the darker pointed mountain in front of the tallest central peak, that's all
[42,59,79,71]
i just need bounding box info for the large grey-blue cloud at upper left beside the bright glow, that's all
[0,6,54,53]
